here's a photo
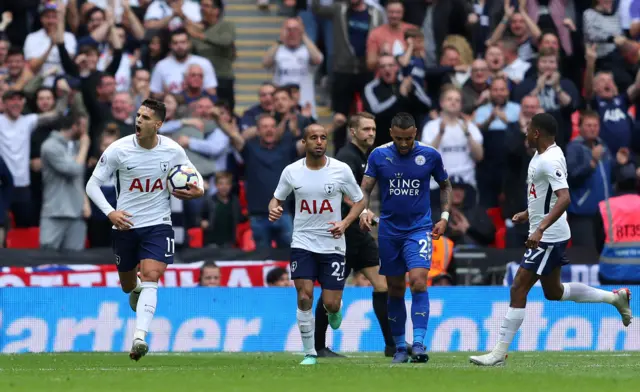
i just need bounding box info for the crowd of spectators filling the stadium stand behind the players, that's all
[0,0,640,260]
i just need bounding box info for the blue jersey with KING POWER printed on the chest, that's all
[364,142,448,237]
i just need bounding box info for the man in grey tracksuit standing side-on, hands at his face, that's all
[40,116,91,250]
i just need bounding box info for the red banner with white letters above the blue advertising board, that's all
[0,260,289,287]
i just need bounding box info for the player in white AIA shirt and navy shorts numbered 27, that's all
[269,124,364,365]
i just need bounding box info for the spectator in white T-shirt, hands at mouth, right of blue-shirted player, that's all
[421,85,484,210]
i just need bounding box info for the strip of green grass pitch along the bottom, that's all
[0,352,640,392]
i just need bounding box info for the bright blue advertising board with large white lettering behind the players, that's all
[0,286,640,353]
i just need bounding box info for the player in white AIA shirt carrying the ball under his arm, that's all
[86,99,204,361]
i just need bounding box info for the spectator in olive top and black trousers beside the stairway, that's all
[187,0,236,111]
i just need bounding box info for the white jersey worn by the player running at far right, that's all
[527,144,571,242]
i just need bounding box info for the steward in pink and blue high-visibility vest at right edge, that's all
[599,173,640,284]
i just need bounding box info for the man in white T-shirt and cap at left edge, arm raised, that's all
[0,87,70,227]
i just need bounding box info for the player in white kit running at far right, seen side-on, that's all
[469,113,632,366]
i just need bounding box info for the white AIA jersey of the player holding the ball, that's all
[93,135,193,229]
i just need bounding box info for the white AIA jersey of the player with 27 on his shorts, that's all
[273,157,363,255]
